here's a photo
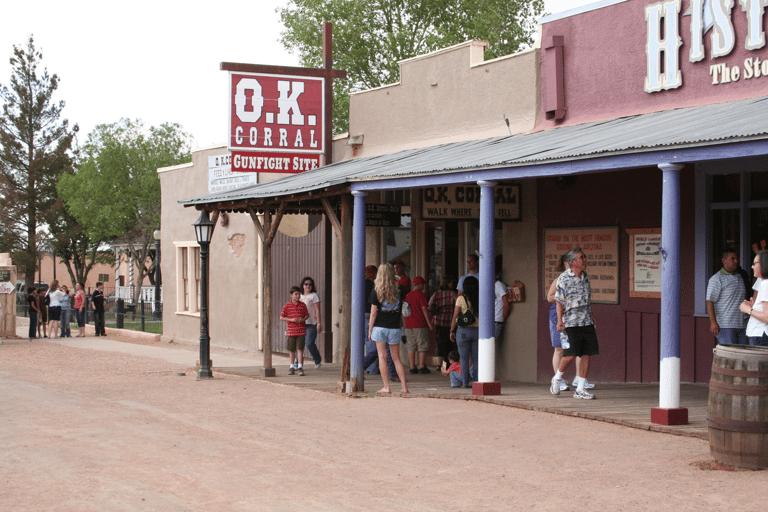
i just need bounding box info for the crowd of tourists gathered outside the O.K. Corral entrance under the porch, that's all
[363,254,510,393]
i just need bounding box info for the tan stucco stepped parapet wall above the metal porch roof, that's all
[344,41,539,158]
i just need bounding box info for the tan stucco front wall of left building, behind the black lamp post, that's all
[158,146,261,350]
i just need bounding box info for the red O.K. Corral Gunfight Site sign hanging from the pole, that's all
[228,72,325,157]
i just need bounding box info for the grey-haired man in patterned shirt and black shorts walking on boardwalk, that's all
[549,248,600,400]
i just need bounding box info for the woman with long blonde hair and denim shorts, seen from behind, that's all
[368,263,408,393]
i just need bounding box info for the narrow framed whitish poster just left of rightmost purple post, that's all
[627,228,661,299]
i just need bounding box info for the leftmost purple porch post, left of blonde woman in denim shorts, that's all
[349,191,368,391]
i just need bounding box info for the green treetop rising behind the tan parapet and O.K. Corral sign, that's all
[277,0,544,133]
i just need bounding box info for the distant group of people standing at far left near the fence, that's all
[27,279,106,340]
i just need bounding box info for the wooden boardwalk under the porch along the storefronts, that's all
[214,363,709,439]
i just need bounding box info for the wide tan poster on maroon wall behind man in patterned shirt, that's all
[542,226,619,304]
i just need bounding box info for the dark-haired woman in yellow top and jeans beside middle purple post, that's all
[451,275,480,388]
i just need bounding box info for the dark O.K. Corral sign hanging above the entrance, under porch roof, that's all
[422,185,521,220]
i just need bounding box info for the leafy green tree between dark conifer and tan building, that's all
[58,119,192,300]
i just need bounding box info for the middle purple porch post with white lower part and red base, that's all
[472,181,501,395]
